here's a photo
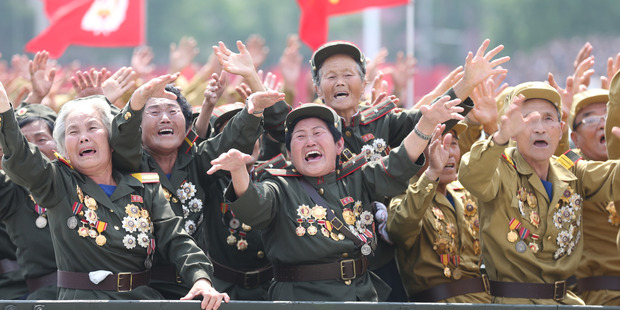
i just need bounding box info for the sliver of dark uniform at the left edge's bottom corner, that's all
[0,223,28,300]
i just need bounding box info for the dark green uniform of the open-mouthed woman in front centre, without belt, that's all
[225,143,424,301]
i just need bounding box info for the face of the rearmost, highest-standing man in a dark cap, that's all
[315,54,366,115]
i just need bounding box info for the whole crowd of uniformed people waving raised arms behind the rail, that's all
[0,32,620,309]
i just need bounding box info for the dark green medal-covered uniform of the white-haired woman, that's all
[0,110,212,300]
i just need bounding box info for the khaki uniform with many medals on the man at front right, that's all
[459,138,620,305]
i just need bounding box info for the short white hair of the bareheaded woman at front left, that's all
[53,95,113,156]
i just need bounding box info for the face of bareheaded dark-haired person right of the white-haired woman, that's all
[142,98,187,154]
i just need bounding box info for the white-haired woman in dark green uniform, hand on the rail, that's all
[0,75,229,309]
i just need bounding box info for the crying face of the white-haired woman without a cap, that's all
[65,107,112,175]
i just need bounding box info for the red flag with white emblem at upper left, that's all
[26,0,145,58]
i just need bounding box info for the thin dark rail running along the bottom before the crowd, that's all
[0,300,620,310]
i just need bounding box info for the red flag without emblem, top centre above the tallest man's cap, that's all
[297,0,410,50]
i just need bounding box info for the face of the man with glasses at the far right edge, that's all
[571,102,607,161]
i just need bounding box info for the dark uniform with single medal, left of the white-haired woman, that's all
[0,171,57,300]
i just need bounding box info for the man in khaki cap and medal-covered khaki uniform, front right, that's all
[459,82,620,305]
